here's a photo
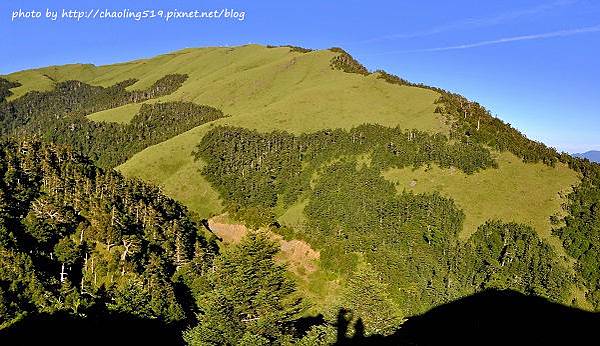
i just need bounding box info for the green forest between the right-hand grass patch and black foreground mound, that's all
[302,160,573,314]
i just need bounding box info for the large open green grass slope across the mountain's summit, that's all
[7,45,446,132]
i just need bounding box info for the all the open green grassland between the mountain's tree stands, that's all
[7,45,578,249]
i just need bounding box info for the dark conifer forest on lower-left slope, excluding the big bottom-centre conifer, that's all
[0,139,215,326]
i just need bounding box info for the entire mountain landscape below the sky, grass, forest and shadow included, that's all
[0,44,600,346]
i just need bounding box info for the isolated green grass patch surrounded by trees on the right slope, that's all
[383,153,579,246]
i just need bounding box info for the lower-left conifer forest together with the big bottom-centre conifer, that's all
[0,139,318,345]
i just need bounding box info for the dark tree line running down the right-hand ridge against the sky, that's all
[332,53,600,309]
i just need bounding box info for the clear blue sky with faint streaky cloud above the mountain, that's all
[0,0,600,152]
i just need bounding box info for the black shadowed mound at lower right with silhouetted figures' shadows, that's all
[338,290,600,345]
